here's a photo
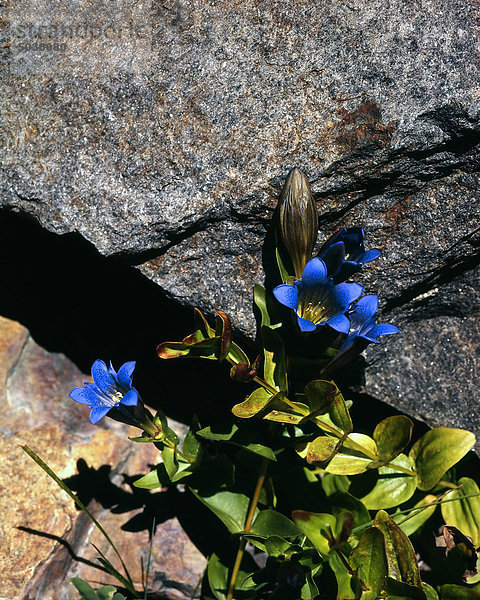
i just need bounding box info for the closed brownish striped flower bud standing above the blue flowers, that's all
[278,168,318,279]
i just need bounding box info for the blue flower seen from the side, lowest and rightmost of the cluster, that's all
[327,294,400,370]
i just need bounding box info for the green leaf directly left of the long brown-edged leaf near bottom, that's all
[349,527,388,600]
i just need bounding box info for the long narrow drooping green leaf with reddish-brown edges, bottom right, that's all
[373,510,422,589]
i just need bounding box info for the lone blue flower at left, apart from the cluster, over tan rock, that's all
[70,360,140,425]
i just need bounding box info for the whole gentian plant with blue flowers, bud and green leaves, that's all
[25,169,480,600]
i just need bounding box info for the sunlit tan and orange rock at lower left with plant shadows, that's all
[0,317,205,600]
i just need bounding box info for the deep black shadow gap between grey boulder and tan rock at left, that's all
[0,211,248,423]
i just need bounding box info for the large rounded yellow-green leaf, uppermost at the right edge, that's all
[409,427,475,491]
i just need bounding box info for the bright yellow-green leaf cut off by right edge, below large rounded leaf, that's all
[440,477,480,548]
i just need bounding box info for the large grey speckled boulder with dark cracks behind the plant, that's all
[0,0,480,440]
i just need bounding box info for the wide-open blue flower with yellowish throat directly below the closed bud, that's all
[273,258,363,333]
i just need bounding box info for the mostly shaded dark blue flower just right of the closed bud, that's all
[318,227,382,283]
